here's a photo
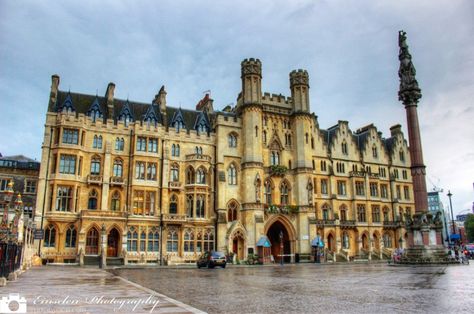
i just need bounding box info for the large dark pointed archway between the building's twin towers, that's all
[265,216,295,263]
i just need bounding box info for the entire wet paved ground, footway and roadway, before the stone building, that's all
[0,263,474,313]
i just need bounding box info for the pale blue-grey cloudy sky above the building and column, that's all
[0,0,474,213]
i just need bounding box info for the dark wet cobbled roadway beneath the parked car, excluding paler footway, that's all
[110,263,474,313]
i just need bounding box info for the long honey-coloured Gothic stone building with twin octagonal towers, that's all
[38,59,414,263]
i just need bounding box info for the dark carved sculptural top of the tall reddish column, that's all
[398,31,421,106]
